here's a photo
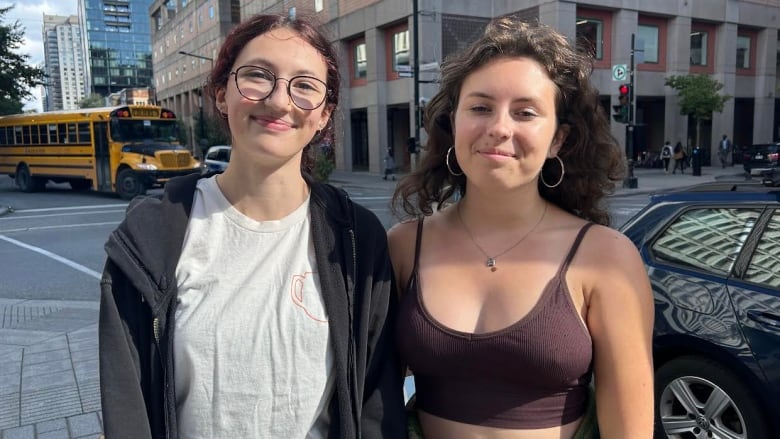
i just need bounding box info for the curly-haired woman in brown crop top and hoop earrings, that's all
[389,17,654,439]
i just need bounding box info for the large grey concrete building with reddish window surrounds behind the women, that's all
[152,0,780,172]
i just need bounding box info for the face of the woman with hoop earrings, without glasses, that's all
[453,58,565,189]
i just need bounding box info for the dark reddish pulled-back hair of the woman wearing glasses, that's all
[204,14,341,173]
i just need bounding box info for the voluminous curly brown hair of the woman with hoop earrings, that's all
[392,17,625,225]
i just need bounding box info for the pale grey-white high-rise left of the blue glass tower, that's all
[43,14,87,111]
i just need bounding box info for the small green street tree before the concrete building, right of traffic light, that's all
[664,75,731,150]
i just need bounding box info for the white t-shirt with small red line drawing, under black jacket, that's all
[174,177,334,438]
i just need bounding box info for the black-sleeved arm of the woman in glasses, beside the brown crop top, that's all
[360,220,406,439]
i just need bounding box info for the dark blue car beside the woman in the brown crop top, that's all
[620,182,780,439]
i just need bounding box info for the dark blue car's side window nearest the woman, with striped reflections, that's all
[651,208,761,275]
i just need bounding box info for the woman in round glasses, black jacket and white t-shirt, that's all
[99,15,406,439]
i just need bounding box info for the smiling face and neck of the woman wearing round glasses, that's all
[215,28,331,170]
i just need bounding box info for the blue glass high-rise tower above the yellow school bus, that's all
[79,0,152,96]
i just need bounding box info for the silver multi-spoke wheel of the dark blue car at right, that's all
[655,356,769,439]
